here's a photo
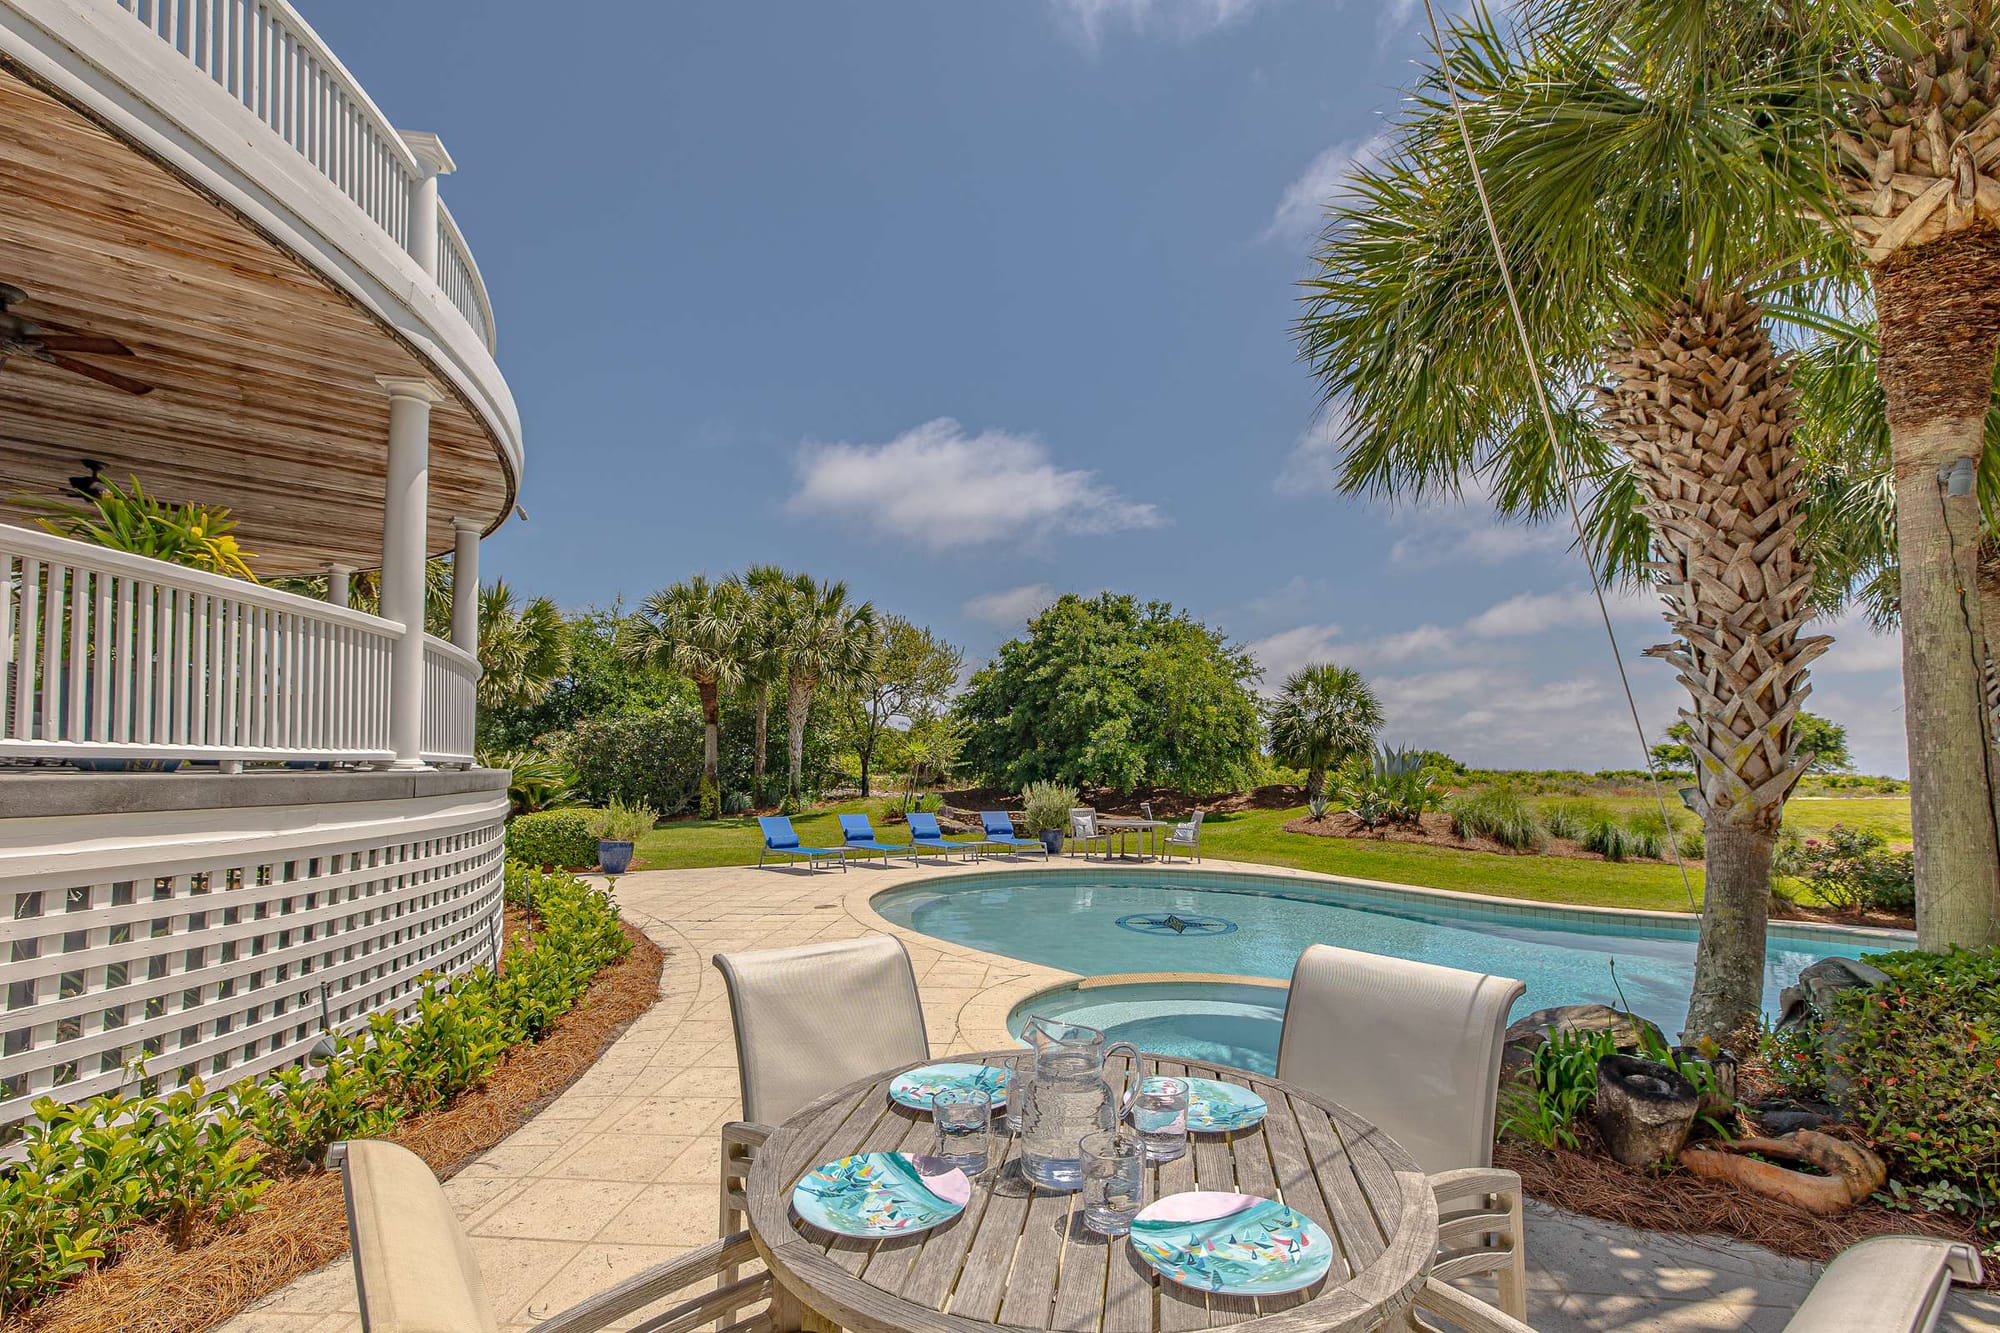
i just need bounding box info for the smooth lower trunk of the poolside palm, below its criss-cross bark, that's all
[1684,819,1778,1041]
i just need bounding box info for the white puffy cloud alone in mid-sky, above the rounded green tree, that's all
[786,416,1166,550]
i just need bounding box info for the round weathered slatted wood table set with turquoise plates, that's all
[746,1051,1438,1333]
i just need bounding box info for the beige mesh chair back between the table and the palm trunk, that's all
[1278,945,1528,1175]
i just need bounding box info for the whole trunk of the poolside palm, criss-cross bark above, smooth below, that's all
[1598,284,1830,1041]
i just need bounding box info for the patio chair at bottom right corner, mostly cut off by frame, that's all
[1416,1235,1984,1333]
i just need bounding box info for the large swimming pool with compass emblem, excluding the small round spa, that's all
[872,867,1914,1037]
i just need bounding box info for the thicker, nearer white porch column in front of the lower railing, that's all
[376,378,444,769]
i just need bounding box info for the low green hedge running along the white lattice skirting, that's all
[0,863,632,1317]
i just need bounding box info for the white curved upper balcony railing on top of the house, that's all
[112,0,494,352]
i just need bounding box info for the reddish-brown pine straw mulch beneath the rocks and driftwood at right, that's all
[1494,1127,2000,1287]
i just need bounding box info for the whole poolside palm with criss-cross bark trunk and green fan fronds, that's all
[1300,6,1838,1039]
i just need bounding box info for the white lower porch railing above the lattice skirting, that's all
[0,524,432,763]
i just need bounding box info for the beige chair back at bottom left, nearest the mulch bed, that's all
[342,1139,498,1333]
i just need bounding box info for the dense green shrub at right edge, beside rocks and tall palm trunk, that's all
[1832,949,2000,1199]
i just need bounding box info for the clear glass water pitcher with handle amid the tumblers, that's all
[1010,1015,1138,1191]
